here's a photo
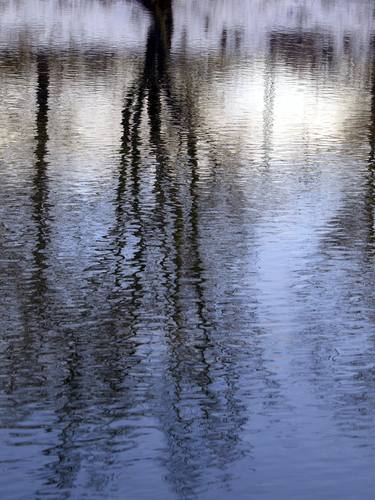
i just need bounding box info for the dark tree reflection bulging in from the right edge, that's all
[296,32,375,446]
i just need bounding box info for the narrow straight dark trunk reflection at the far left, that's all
[2,52,49,402]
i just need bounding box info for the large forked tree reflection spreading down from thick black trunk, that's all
[30,1,277,498]
